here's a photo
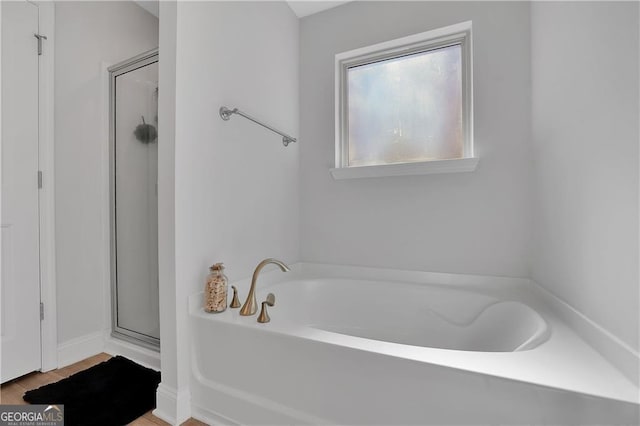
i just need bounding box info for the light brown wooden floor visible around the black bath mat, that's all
[0,353,206,426]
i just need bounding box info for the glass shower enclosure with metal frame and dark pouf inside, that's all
[109,49,160,348]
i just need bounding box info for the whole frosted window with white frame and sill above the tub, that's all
[331,22,477,179]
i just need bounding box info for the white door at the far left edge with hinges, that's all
[0,1,42,382]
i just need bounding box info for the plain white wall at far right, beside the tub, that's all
[532,2,640,356]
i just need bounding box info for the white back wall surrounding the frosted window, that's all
[300,2,531,277]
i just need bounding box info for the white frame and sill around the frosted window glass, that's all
[331,21,478,179]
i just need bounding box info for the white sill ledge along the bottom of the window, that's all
[330,157,479,180]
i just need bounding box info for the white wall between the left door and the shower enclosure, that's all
[55,2,158,343]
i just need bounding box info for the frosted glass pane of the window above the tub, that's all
[347,45,464,166]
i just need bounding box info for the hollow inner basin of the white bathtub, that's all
[269,277,550,352]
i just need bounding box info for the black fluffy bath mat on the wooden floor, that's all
[23,356,160,426]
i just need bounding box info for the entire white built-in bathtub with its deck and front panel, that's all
[189,264,638,424]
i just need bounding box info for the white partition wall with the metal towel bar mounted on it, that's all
[158,2,299,421]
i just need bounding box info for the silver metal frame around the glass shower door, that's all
[108,48,160,351]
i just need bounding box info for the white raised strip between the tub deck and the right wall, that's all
[531,280,640,386]
